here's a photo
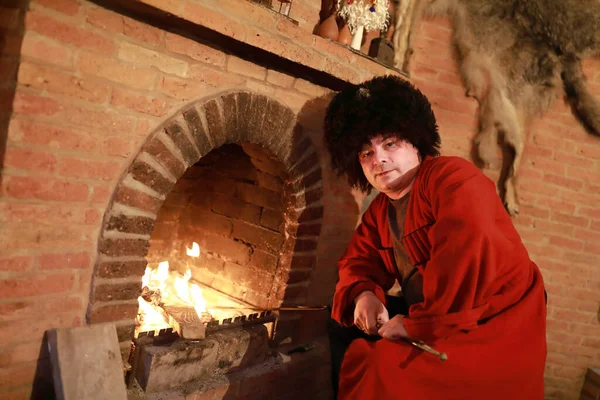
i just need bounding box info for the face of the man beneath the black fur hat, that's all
[358,135,421,199]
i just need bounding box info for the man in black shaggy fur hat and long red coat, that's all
[325,76,546,400]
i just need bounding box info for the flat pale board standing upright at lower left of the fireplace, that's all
[48,323,127,400]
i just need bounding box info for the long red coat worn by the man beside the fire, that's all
[333,157,546,400]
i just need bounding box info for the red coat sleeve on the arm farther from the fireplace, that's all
[404,158,520,340]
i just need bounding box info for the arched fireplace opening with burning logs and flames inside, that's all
[128,143,295,392]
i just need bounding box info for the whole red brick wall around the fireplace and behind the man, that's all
[0,0,600,399]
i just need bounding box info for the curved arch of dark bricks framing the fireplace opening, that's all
[87,91,323,334]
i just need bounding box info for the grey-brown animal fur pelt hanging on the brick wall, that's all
[405,0,600,215]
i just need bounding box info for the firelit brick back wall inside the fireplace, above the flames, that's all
[146,144,297,309]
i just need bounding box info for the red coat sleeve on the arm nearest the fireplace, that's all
[331,195,395,326]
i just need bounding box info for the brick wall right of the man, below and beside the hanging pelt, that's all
[410,18,600,400]
